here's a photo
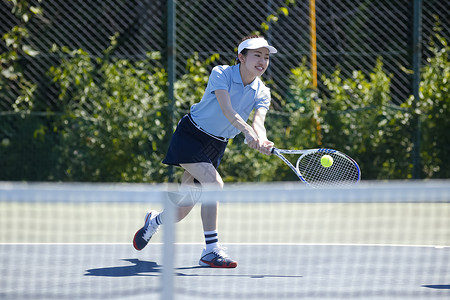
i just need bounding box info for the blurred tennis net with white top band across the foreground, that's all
[0,181,450,299]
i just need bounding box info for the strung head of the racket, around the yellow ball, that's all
[297,152,359,186]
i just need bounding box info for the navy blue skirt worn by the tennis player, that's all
[163,115,228,169]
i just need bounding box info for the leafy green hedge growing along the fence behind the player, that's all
[0,31,450,182]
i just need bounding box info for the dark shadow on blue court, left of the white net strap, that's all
[84,258,161,277]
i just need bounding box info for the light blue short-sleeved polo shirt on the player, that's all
[191,65,270,138]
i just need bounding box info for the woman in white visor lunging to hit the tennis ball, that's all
[133,35,277,268]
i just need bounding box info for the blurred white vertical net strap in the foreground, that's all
[161,192,176,300]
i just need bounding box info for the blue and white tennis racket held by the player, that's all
[272,148,361,187]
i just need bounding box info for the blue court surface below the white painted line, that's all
[0,244,450,299]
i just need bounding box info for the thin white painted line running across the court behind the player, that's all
[0,243,450,249]
